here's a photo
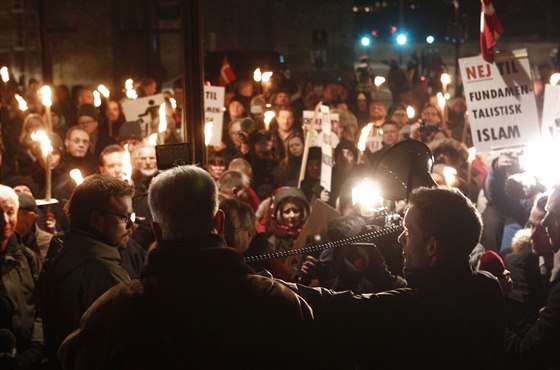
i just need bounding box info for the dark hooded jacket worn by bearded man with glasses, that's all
[39,231,130,366]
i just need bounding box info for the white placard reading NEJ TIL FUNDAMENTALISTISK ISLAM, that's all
[459,49,540,152]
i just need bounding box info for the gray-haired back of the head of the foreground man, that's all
[148,165,218,240]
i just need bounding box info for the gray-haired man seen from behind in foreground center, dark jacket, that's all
[59,166,313,370]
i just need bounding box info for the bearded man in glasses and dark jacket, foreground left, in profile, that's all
[39,175,134,364]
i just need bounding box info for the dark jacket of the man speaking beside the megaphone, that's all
[288,264,505,370]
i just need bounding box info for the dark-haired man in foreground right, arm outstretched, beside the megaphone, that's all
[292,188,505,370]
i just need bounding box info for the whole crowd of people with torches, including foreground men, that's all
[0,63,560,369]
